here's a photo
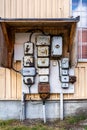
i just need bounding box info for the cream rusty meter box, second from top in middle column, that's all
[38,46,49,57]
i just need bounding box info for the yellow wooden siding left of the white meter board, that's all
[0,63,22,100]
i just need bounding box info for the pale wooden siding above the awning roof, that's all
[0,0,70,18]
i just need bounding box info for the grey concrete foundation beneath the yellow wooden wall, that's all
[0,100,87,120]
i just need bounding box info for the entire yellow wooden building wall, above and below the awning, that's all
[0,0,87,100]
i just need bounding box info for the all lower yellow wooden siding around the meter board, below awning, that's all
[0,62,87,100]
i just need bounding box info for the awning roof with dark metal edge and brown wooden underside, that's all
[0,16,80,29]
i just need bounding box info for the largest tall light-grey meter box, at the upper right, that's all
[51,36,63,57]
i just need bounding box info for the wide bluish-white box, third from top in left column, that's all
[22,67,36,76]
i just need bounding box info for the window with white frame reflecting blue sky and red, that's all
[72,0,87,61]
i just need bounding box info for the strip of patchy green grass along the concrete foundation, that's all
[0,115,87,130]
